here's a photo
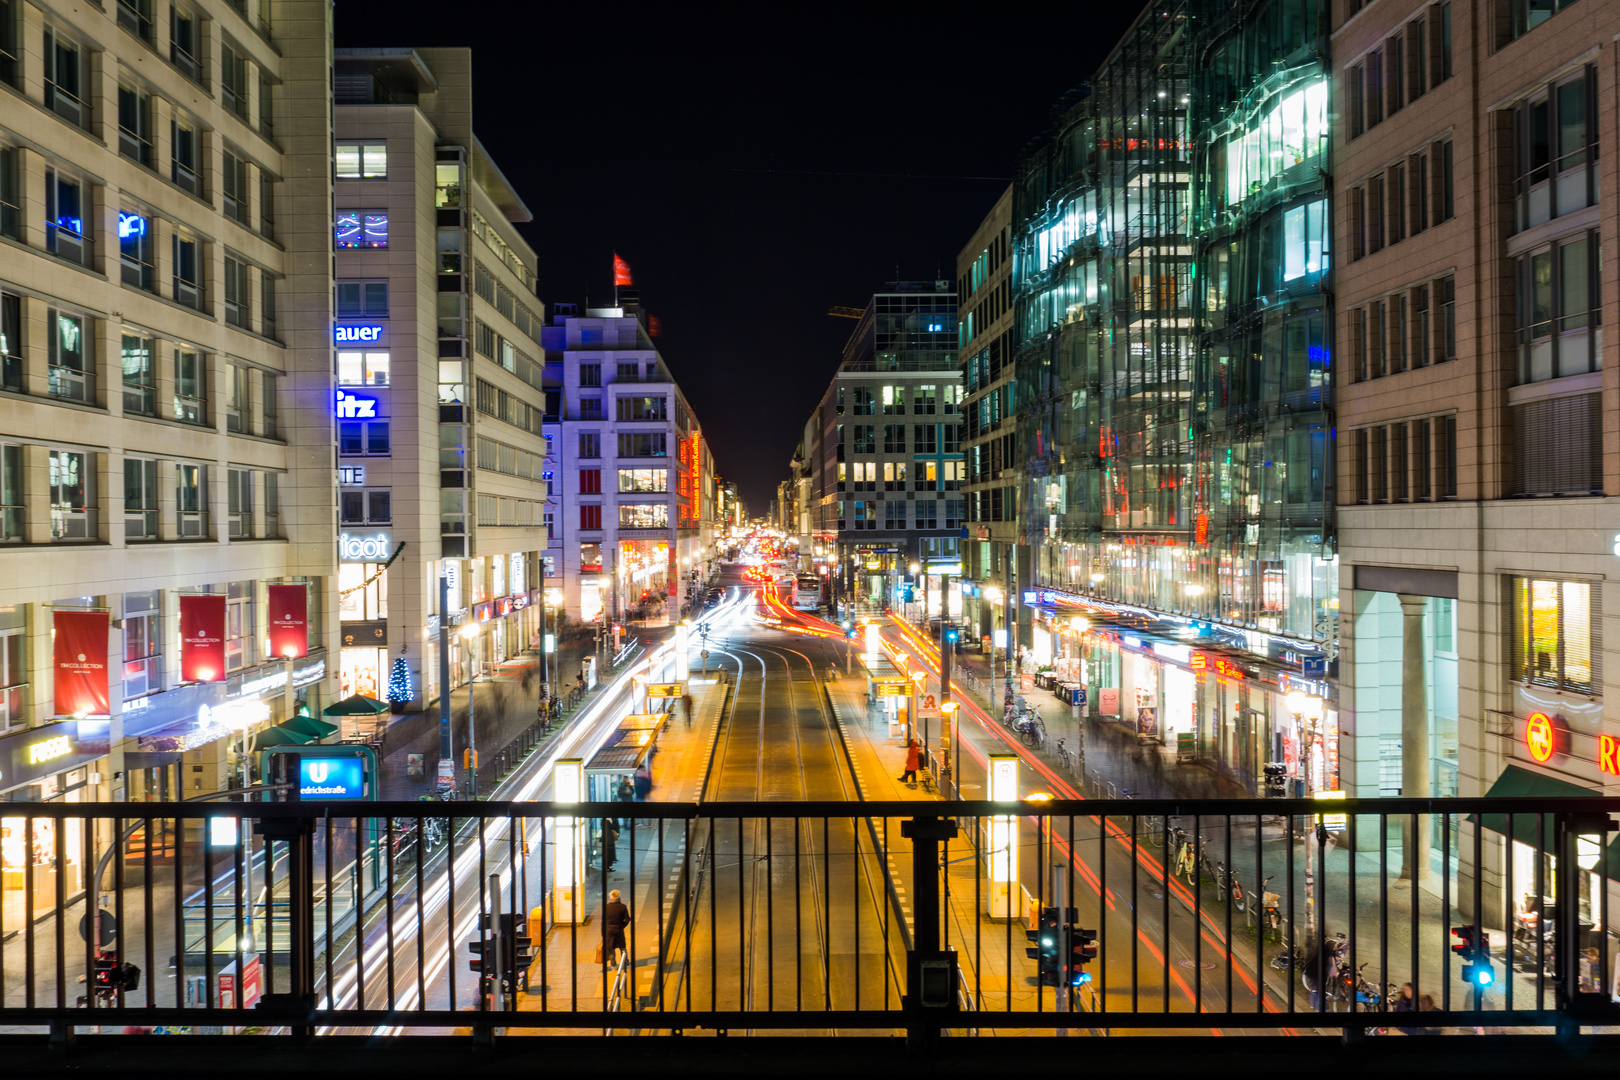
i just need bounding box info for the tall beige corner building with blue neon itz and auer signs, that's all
[332,49,548,708]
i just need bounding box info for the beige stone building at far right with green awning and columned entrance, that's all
[1333,0,1620,918]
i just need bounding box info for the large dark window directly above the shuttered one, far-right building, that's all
[1516,232,1602,384]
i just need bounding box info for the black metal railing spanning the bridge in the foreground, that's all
[0,798,1620,1038]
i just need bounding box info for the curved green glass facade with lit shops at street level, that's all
[1011,0,1338,790]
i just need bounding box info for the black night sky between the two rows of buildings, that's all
[335,0,1142,515]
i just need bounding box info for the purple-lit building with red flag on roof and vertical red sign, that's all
[544,299,709,623]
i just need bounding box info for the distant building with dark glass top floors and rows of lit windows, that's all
[812,282,966,612]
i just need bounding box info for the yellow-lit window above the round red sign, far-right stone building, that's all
[1511,578,1604,696]
